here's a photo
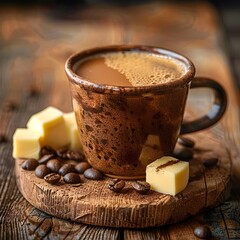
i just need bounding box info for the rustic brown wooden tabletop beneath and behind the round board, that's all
[0,3,240,239]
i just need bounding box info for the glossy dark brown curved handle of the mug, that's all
[180,77,227,134]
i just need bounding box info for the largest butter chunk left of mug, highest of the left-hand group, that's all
[27,106,70,149]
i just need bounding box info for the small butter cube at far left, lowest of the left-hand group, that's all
[13,128,41,159]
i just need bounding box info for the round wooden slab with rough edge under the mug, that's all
[16,134,231,228]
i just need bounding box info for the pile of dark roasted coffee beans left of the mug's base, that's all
[22,146,103,184]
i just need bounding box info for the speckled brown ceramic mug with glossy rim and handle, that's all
[65,45,227,179]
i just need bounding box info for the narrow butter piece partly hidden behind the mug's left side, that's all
[63,112,82,152]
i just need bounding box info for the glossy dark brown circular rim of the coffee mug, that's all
[65,44,195,95]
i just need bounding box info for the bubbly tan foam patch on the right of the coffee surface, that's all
[102,52,186,86]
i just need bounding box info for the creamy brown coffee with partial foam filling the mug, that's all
[76,51,186,87]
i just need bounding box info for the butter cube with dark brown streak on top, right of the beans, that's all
[146,156,189,196]
